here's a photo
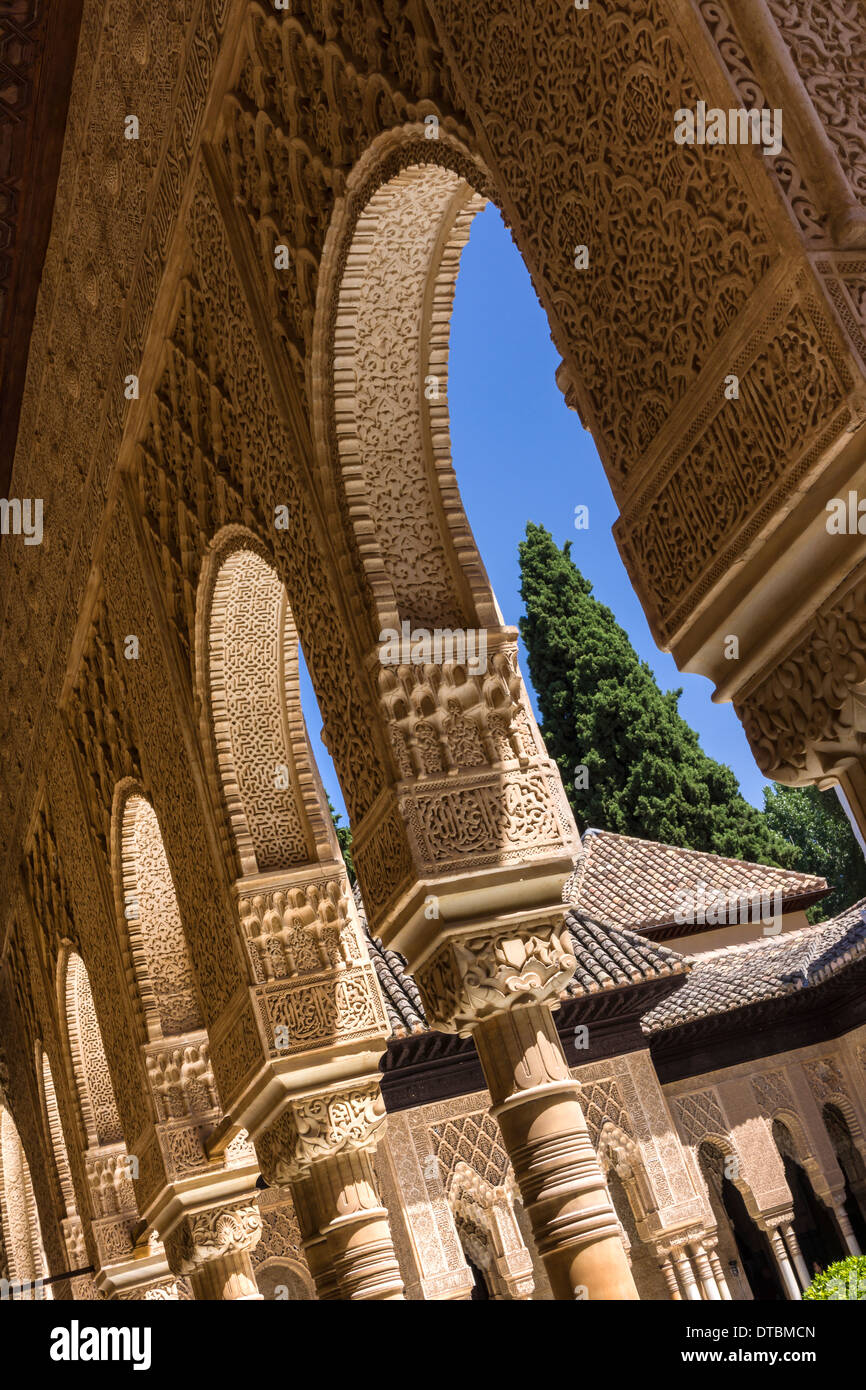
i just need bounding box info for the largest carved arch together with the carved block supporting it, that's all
[310,125,580,978]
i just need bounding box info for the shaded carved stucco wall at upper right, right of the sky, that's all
[430,0,866,806]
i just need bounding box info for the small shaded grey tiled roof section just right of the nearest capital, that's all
[562,912,691,999]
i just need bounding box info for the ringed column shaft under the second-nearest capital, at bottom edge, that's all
[310,1151,405,1301]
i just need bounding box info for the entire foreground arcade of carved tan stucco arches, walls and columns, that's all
[0,0,866,1298]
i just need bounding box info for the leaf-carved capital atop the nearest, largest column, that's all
[416,920,577,1033]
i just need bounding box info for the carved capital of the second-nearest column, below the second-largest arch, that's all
[256,1077,385,1186]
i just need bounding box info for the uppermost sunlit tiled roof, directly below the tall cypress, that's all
[566,830,828,931]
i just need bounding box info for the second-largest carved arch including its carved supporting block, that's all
[196,525,388,1134]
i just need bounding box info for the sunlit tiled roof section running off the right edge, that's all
[642,898,866,1034]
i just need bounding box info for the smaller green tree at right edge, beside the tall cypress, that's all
[763,783,866,922]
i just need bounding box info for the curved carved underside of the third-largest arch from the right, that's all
[111,780,203,1038]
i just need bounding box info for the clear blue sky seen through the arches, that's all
[302,207,766,819]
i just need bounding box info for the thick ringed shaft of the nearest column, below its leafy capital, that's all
[474,1004,638,1300]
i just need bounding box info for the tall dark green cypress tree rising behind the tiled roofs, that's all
[520,523,798,867]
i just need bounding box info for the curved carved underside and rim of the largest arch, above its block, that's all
[311,125,502,641]
